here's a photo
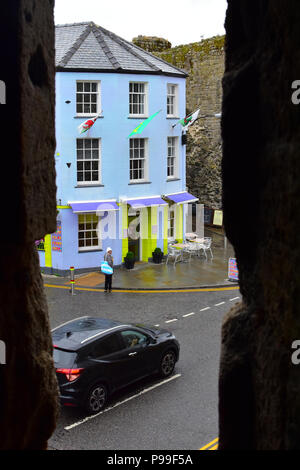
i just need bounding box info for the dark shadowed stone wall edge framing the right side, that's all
[219,0,300,450]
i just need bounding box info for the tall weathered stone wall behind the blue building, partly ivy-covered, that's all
[155,36,225,209]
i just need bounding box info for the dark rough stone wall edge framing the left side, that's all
[0,0,59,450]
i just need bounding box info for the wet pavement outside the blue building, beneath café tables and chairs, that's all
[42,228,236,290]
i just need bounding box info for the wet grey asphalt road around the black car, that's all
[46,288,240,450]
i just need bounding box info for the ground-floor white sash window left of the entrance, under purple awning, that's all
[78,214,101,251]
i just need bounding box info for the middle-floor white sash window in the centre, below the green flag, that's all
[130,139,147,182]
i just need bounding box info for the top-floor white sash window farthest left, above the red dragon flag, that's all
[76,81,100,115]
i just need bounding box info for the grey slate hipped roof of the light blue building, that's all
[55,22,187,77]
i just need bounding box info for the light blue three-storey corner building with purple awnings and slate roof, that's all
[38,23,196,274]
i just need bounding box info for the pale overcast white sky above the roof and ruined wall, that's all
[54,0,227,47]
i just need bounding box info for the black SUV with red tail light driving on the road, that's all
[52,317,180,413]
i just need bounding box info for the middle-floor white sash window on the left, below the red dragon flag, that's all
[77,139,100,184]
